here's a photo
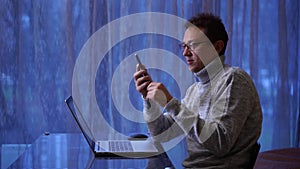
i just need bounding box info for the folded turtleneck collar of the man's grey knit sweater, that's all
[194,55,225,84]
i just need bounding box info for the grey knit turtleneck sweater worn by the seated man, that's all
[144,56,262,168]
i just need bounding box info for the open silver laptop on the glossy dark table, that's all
[65,96,160,158]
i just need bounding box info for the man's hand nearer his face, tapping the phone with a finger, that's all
[146,82,173,107]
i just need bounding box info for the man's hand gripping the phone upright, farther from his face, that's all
[133,64,152,98]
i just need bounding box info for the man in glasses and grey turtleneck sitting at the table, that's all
[134,13,262,168]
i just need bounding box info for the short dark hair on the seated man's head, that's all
[185,13,228,55]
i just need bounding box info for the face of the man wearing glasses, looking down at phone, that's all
[183,27,218,73]
